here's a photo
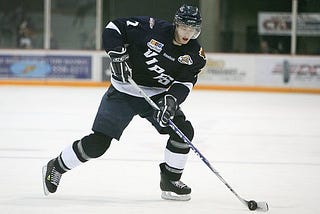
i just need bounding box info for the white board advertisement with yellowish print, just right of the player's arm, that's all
[198,54,254,86]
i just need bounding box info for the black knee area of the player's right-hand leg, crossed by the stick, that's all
[166,120,194,154]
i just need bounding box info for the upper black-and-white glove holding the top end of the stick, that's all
[108,47,132,82]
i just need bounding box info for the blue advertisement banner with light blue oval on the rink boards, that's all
[0,55,92,79]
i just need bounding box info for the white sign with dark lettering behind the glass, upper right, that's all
[258,12,320,36]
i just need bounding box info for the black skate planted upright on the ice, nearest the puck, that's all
[160,164,191,201]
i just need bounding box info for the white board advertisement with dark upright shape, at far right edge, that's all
[256,56,320,88]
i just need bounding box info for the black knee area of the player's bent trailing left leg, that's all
[79,132,112,158]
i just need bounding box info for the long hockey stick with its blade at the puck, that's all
[128,77,269,212]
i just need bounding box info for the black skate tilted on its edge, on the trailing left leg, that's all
[42,159,62,195]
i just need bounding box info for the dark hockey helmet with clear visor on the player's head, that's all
[173,4,202,39]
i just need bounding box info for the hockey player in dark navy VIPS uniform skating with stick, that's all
[42,5,206,200]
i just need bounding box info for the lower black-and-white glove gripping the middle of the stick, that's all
[155,94,178,127]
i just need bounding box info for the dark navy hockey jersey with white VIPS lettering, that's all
[103,16,206,102]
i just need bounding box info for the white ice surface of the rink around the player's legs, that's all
[0,86,320,214]
